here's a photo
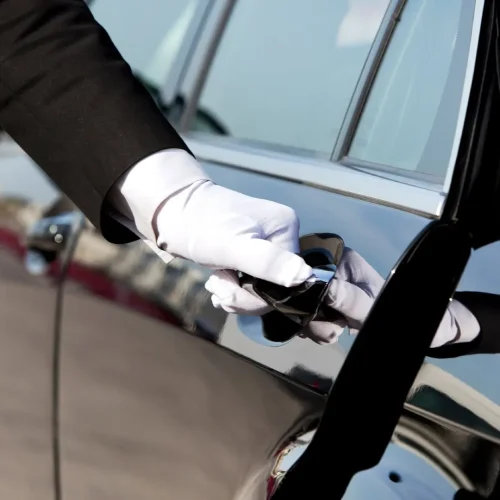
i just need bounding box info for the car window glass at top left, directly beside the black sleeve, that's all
[88,0,208,114]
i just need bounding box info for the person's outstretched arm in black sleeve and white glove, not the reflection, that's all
[0,0,311,300]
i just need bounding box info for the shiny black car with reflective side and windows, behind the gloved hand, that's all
[0,0,500,500]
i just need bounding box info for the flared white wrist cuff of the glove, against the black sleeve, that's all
[108,149,210,242]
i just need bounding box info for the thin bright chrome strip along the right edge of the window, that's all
[443,0,485,193]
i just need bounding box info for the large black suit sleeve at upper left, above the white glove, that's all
[0,0,193,243]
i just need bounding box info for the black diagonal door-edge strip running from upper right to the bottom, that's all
[277,3,500,499]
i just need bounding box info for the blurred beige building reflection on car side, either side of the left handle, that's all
[0,197,226,339]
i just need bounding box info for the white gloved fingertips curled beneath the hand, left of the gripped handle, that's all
[205,270,271,316]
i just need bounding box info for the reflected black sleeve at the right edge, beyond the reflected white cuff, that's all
[429,292,500,358]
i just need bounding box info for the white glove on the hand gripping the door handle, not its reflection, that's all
[114,149,311,292]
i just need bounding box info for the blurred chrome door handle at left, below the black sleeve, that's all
[24,211,84,276]
